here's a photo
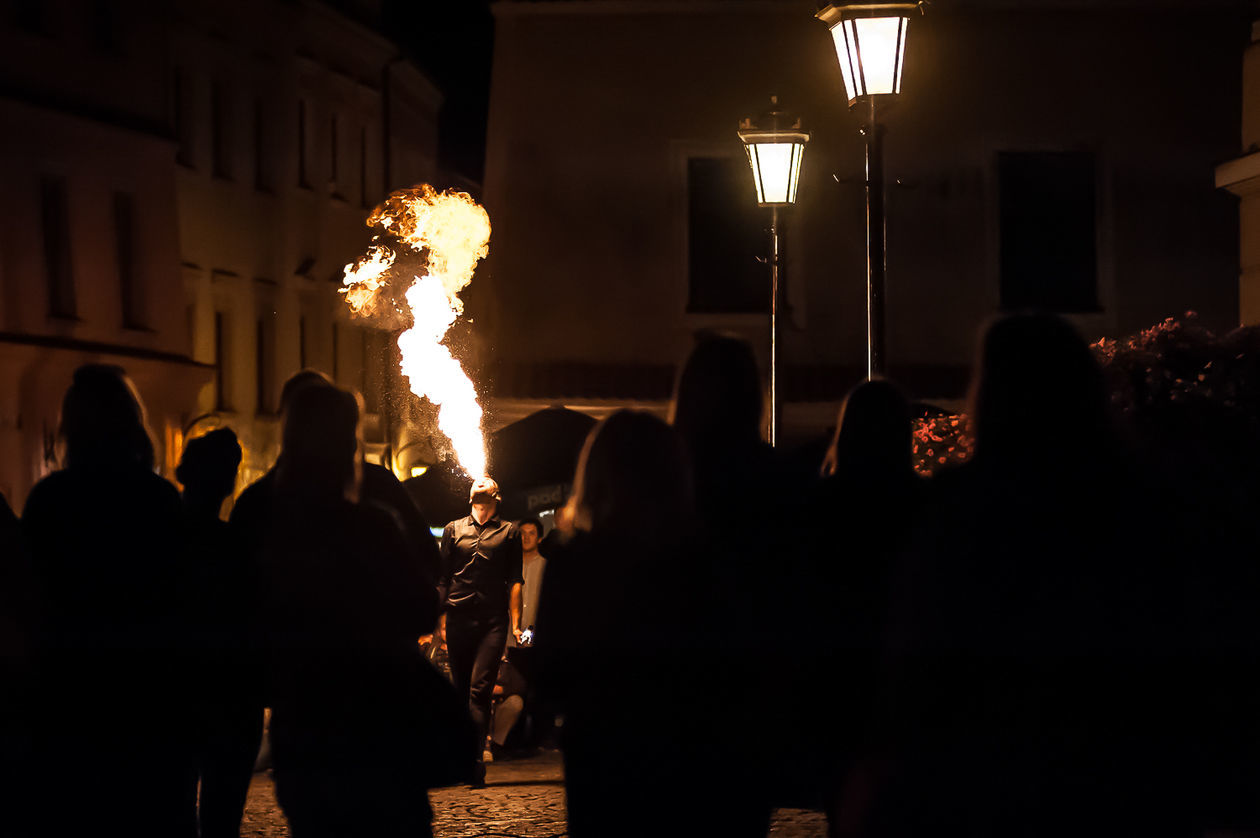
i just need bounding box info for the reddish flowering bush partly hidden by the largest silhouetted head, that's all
[914,311,1260,475]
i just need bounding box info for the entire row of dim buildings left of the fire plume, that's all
[0,0,441,509]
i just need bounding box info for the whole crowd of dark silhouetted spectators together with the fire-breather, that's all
[0,314,1260,838]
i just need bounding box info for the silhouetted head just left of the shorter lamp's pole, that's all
[670,335,762,452]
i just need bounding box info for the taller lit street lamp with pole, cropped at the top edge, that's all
[815,3,922,378]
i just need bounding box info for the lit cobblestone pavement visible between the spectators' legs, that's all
[241,752,827,838]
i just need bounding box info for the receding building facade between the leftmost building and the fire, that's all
[170,3,442,481]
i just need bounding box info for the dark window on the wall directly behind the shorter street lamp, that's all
[687,158,770,313]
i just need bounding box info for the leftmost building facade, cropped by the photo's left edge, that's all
[0,3,210,509]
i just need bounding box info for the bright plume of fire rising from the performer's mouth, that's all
[341,184,490,478]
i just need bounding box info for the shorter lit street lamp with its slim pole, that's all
[738,96,809,445]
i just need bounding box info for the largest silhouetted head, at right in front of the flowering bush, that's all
[970,314,1110,464]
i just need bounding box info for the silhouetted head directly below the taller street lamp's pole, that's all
[825,379,912,476]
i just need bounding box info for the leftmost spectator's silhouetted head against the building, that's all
[57,364,154,469]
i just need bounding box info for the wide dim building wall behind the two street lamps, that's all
[475,0,1247,441]
